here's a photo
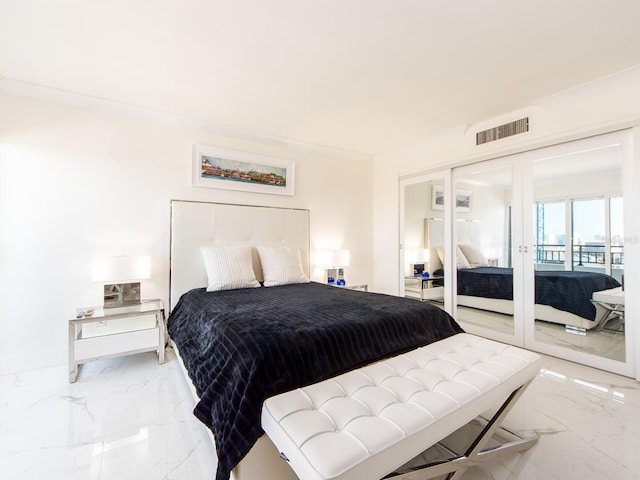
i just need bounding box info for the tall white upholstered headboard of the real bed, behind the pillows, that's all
[169,200,309,309]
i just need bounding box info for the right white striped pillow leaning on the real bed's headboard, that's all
[258,247,309,287]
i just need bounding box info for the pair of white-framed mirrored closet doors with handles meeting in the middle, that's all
[452,132,636,376]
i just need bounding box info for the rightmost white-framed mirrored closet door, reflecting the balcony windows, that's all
[524,133,633,374]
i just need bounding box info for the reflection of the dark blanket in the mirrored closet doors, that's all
[458,267,620,320]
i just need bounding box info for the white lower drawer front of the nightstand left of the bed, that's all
[73,328,160,362]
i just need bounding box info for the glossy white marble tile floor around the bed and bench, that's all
[0,352,640,480]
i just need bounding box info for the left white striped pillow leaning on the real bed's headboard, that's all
[200,246,260,292]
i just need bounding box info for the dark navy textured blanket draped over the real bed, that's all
[168,283,462,480]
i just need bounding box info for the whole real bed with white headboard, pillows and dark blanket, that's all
[168,201,462,480]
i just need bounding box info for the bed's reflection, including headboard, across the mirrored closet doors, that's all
[425,219,620,330]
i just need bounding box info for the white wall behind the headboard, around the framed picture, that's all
[0,95,372,373]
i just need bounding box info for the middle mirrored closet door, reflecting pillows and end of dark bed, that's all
[451,158,524,346]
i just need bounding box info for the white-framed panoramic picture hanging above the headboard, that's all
[192,145,295,196]
